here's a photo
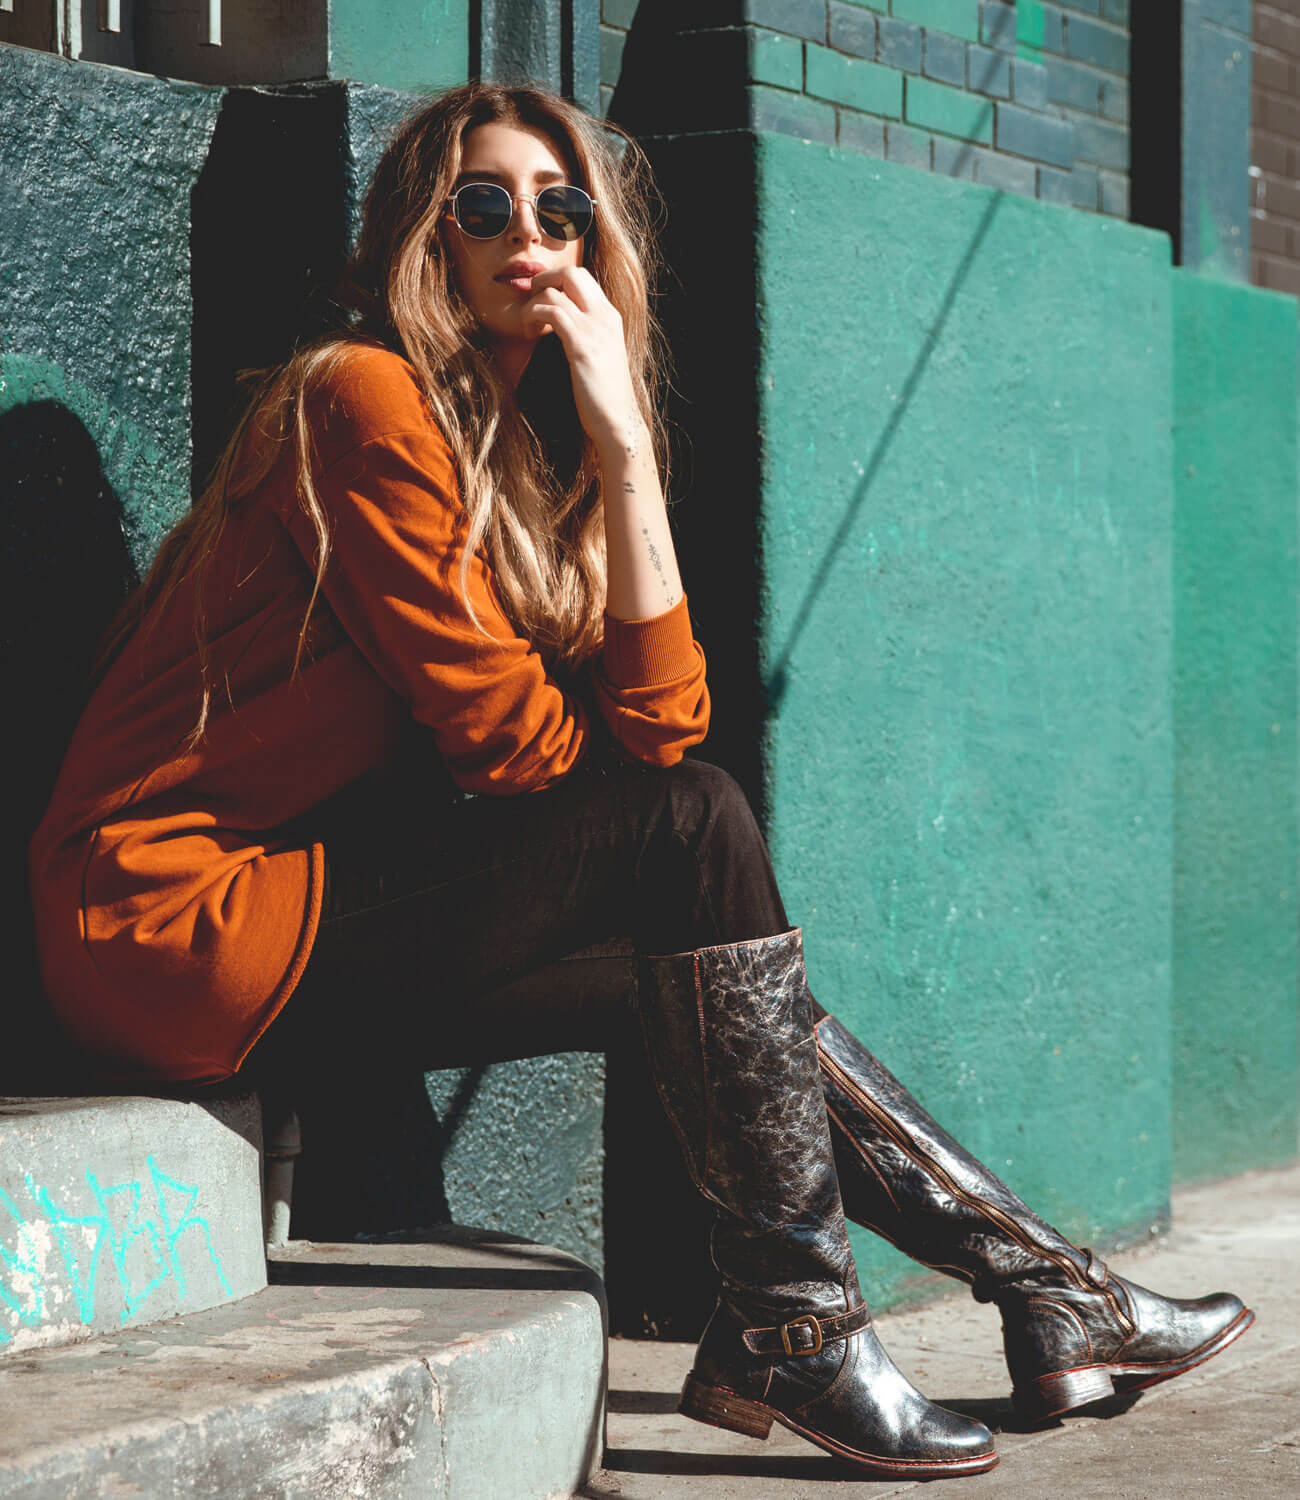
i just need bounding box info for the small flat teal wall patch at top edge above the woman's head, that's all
[330,0,469,93]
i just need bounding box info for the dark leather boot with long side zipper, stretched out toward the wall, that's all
[816,1016,1255,1421]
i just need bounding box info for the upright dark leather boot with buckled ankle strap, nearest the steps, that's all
[639,930,997,1479]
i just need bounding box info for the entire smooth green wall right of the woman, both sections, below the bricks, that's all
[651,134,1297,1301]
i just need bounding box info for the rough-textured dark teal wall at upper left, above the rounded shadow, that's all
[0,47,220,566]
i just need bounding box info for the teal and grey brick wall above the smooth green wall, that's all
[600,0,1127,218]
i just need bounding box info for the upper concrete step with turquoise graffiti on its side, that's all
[0,1094,267,1370]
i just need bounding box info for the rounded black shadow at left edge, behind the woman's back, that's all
[0,401,135,1092]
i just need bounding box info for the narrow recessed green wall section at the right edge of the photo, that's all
[1173,272,1297,1179]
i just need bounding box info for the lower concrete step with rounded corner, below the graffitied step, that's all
[0,1230,606,1500]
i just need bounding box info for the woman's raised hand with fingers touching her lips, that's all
[525,266,648,465]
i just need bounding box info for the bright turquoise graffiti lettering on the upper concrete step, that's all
[0,1157,234,1349]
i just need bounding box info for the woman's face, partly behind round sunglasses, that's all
[442,122,582,363]
